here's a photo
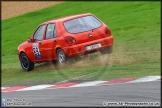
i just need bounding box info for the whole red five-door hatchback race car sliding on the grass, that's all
[17,13,113,71]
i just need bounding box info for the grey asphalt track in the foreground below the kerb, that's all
[1,80,161,107]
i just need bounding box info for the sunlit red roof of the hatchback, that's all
[41,13,93,25]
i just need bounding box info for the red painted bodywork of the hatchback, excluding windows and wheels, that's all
[18,13,113,62]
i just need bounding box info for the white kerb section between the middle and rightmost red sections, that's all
[71,81,107,87]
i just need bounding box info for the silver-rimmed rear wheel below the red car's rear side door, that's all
[57,49,67,65]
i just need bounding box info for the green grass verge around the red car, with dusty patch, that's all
[1,1,161,86]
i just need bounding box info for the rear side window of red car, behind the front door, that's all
[46,24,56,39]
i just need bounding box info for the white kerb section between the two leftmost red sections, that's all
[16,85,53,91]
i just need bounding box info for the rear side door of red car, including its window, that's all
[39,23,56,60]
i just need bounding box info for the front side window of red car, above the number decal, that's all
[34,25,45,41]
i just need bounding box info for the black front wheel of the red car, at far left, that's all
[20,53,34,71]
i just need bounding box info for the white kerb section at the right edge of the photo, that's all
[126,76,161,83]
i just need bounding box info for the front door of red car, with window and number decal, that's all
[32,24,46,61]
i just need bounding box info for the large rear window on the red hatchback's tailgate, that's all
[64,16,102,33]
